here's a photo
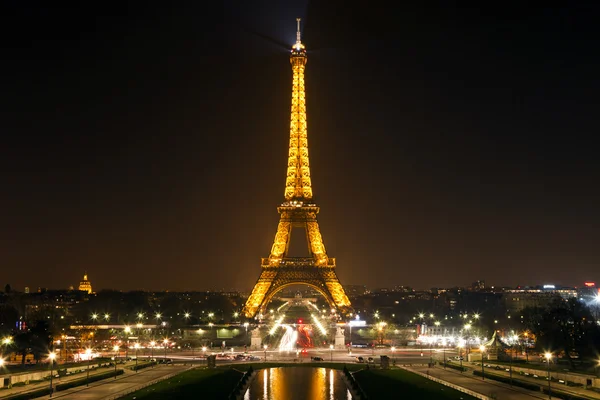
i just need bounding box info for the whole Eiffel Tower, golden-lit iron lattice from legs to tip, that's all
[243,18,350,318]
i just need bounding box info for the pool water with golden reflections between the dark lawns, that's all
[244,367,352,400]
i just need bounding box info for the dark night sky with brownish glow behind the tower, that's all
[0,0,600,290]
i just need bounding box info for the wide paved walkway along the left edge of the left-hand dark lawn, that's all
[39,365,192,400]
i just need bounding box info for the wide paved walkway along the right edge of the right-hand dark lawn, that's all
[406,366,556,400]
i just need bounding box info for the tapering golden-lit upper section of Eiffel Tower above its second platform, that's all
[285,18,312,201]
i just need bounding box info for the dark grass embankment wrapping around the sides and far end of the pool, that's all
[124,362,473,400]
